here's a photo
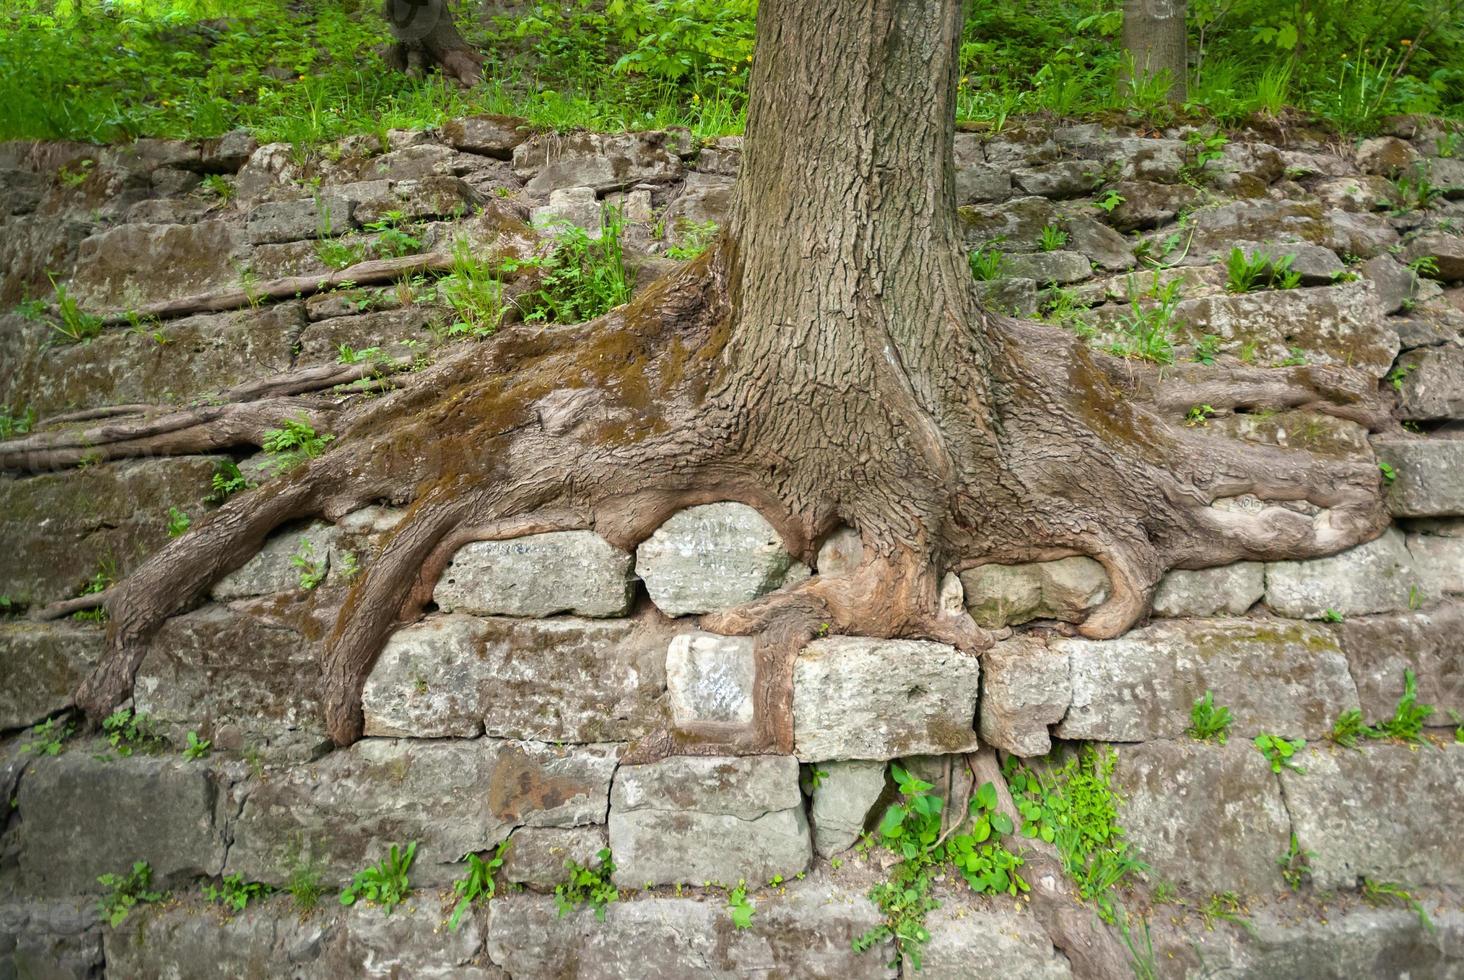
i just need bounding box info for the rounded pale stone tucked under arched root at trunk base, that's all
[635,502,802,615]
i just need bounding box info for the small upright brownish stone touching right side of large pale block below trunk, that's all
[979,637,1073,759]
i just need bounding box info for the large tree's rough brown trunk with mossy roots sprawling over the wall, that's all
[0,0,1386,976]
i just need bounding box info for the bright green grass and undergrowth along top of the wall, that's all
[0,0,1464,146]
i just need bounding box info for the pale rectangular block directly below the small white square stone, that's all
[610,756,813,888]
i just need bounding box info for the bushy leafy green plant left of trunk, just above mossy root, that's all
[504,205,635,324]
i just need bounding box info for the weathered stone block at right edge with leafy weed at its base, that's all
[1341,602,1464,725]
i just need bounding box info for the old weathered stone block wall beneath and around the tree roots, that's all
[0,110,1464,980]
